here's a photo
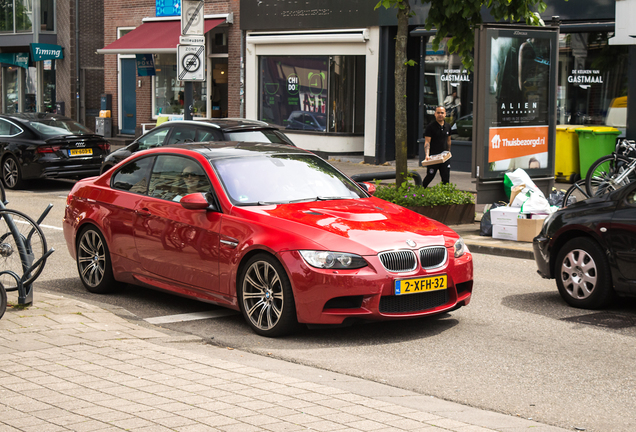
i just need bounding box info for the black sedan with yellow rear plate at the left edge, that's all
[0,113,110,189]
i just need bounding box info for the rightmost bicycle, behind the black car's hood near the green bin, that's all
[585,139,636,196]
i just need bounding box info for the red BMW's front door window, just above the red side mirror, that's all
[148,155,211,201]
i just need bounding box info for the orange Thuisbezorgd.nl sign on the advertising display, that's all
[488,126,549,162]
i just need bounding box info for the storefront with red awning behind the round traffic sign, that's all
[97,9,233,134]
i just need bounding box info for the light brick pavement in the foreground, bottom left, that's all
[0,291,564,432]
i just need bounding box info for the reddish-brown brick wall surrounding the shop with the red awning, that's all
[103,0,241,131]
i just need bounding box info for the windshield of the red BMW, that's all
[212,154,366,205]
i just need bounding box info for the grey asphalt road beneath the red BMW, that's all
[8,181,636,432]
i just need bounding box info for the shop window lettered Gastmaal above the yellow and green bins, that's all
[557,32,628,132]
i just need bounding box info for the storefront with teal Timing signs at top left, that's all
[0,0,59,113]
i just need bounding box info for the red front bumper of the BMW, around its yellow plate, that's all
[279,250,473,324]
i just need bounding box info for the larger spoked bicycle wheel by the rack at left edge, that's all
[0,209,48,290]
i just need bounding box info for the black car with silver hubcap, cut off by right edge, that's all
[533,183,636,309]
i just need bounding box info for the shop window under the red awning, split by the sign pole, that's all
[154,54,207,117]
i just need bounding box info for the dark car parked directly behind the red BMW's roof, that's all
[101,119,295,173]
